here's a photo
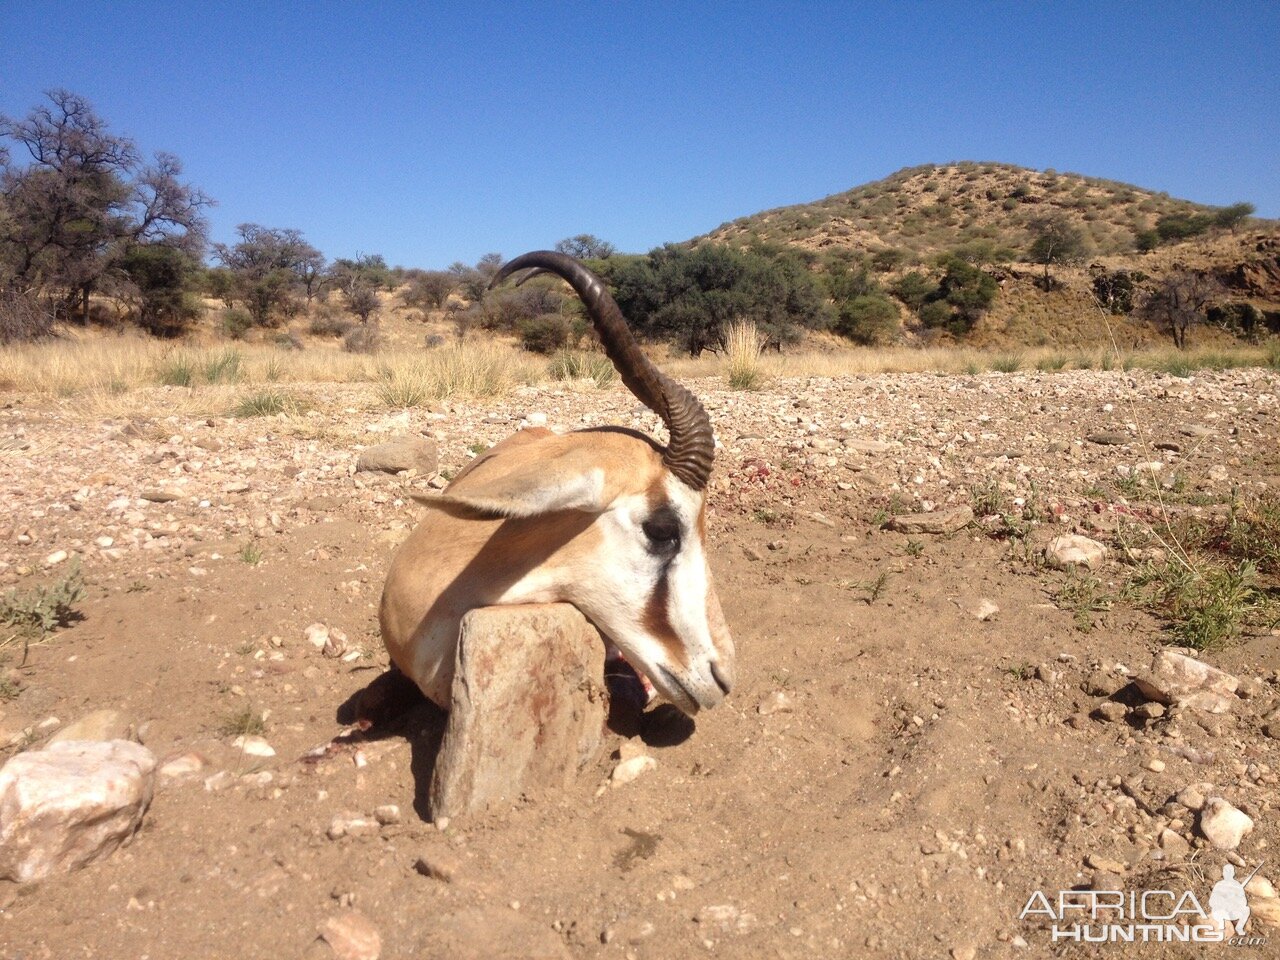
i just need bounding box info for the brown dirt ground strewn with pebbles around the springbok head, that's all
[0,370,1280,960]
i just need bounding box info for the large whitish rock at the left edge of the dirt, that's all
[0,740,156,883]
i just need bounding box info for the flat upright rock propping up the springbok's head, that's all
[430,603,608,817]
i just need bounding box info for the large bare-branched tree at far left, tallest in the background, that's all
[0,90,212,320]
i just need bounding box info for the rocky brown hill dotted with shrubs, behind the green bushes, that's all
[690,161,1280,346]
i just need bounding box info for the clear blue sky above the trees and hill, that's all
[0,0,1280,268]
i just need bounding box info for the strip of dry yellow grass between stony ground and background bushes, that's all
[0,325,1280,416]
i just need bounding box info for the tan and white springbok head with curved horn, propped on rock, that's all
[380,251,733,714]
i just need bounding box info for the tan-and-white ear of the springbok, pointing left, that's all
[411,449,608,517]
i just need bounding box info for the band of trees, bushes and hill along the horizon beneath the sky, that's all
[0,91,1280,356]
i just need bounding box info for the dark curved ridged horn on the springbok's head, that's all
[489,250,716,490]
